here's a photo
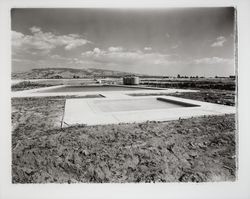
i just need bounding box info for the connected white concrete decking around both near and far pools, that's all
[12,85,236,127]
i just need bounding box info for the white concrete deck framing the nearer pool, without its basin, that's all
[63,95,236,127]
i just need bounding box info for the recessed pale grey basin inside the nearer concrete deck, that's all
[94,98,196,112]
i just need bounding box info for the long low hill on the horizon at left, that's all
[11,68,139,79]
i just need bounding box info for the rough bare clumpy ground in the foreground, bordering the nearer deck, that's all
[12,93,236,183]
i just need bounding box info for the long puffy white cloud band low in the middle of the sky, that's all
[78,48,182,74]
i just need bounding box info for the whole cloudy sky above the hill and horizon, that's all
[11,7,235,76]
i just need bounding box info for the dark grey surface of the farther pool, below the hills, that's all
[39,86,158,93]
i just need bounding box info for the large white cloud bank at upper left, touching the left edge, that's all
[12,26,91,54]
